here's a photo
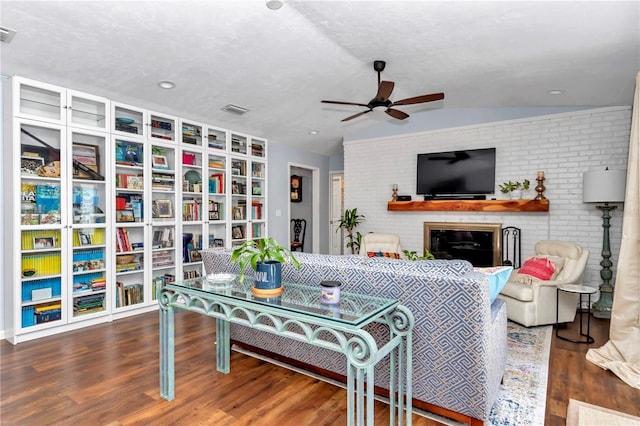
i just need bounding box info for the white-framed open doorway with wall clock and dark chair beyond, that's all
[288,163,320,253]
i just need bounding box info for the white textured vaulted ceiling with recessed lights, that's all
[0,0,640,154]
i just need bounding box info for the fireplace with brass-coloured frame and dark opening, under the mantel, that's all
[424,222,502,266]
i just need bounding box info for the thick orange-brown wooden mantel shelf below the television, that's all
[387,200,549,212]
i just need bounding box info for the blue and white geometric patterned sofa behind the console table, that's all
[202,248,507,423]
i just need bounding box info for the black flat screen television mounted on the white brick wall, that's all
[416,148,496,199]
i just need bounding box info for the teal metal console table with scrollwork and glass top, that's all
[158,278,414,425]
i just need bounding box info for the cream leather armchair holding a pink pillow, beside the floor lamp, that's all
[498,240,589,327]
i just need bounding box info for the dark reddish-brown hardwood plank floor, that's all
[0,312,640,426]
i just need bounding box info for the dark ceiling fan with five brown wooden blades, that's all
[322,61,444,121]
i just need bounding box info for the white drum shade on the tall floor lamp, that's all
[582,170,627,203]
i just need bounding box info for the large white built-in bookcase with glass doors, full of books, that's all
[3,77,267,344]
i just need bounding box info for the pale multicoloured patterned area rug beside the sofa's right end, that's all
[489,321,552,426]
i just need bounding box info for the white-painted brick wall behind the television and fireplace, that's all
[344,107,631,296]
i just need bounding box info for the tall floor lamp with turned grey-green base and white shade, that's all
[582,167,627,318]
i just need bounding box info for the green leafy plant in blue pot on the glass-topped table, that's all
[231,238,300,297]
